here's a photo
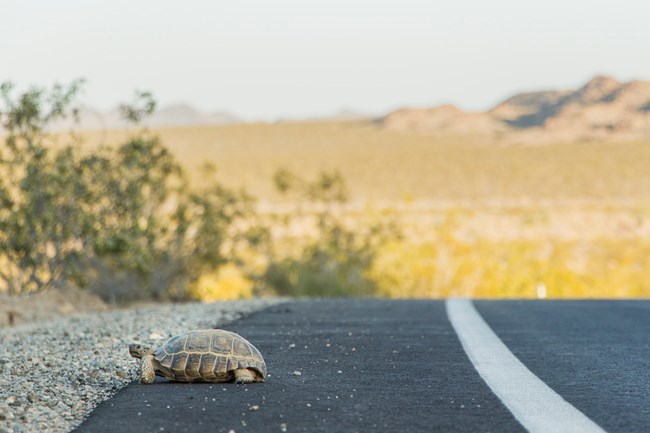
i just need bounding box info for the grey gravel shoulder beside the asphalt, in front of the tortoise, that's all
[0,299,281,433]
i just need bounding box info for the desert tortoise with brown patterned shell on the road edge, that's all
[129,329,266,383]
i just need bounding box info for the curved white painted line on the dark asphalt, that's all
[446,299,604,433]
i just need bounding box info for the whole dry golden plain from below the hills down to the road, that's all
[73,122,650,297]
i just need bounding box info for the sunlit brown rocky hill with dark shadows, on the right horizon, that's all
[380,76,650,140]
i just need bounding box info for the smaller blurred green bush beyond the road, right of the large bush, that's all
[254,169,400,296]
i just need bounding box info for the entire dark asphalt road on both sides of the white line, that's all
[78,300,650,433]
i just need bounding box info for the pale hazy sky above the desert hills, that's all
[0,0,650,120]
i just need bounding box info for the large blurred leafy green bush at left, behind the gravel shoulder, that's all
[0,82,253,302]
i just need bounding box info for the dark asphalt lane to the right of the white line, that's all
[475,301,650,432]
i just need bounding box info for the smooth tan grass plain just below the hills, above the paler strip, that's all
[82,122,650,203]
